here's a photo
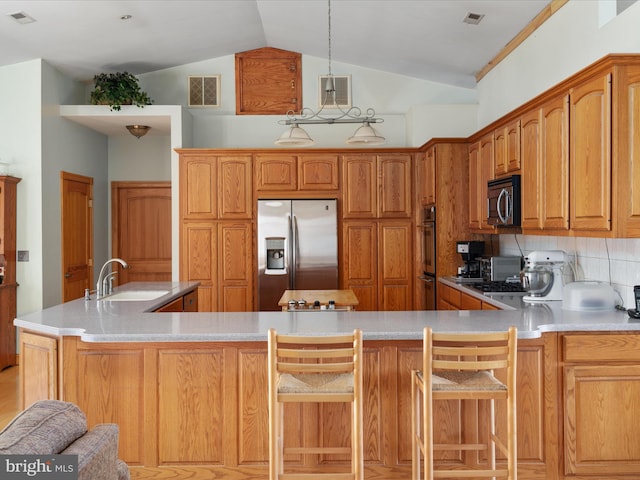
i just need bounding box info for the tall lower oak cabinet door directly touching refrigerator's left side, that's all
[218,222,254,312]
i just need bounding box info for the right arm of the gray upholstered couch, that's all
[60,423,129,480]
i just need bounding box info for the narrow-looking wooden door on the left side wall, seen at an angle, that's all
[60,172,93,302]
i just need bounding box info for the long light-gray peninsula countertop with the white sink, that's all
[14,282,640,342]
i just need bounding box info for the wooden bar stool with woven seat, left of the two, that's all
[269,329,364,480]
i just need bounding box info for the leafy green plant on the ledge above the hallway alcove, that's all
[91,72,153,110]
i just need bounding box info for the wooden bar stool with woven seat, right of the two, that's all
[411,327,517,480]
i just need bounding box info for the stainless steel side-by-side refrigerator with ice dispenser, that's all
[257,199,338,310]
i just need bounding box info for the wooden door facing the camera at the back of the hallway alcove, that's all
[111,182,171,285]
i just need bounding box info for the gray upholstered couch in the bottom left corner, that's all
[0,400,130,480]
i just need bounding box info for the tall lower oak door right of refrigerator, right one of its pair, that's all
[378,221,413,310]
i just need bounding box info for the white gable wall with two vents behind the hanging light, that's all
[139,51,476,148]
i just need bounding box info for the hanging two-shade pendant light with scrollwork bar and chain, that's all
[276,0,385,146]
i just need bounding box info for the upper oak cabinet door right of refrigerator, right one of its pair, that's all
[378,154,412,218]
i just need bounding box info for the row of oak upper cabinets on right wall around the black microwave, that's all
[478,55,640,238]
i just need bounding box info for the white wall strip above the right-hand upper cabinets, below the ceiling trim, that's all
[477,0,640,128]
